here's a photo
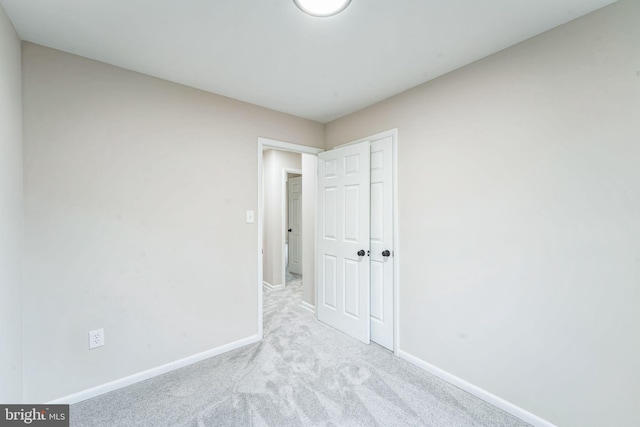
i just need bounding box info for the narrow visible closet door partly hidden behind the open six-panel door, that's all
[371,137,394,350]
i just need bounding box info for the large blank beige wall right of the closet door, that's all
[326,0,640,427]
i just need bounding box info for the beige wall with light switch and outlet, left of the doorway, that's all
[23,43,324,402]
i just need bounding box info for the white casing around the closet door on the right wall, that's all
[324,128,400,356]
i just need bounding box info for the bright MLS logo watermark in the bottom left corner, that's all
[0,405,69,427]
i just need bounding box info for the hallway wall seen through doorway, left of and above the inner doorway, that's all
[263,150,302,286]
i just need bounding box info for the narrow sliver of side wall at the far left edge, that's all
[0,6,23,403]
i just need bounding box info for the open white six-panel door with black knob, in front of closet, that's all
[316,142,371,343]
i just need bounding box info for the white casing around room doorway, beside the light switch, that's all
[257,137,325,339]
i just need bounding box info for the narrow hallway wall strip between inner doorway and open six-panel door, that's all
[302,154,317,305]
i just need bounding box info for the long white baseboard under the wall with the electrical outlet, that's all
[48,335,260,405]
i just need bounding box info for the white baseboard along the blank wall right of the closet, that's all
[397,350,557,427]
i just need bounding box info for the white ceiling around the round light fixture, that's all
[0,0,613,123]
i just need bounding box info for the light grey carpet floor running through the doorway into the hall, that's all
[70,275,528,427]
